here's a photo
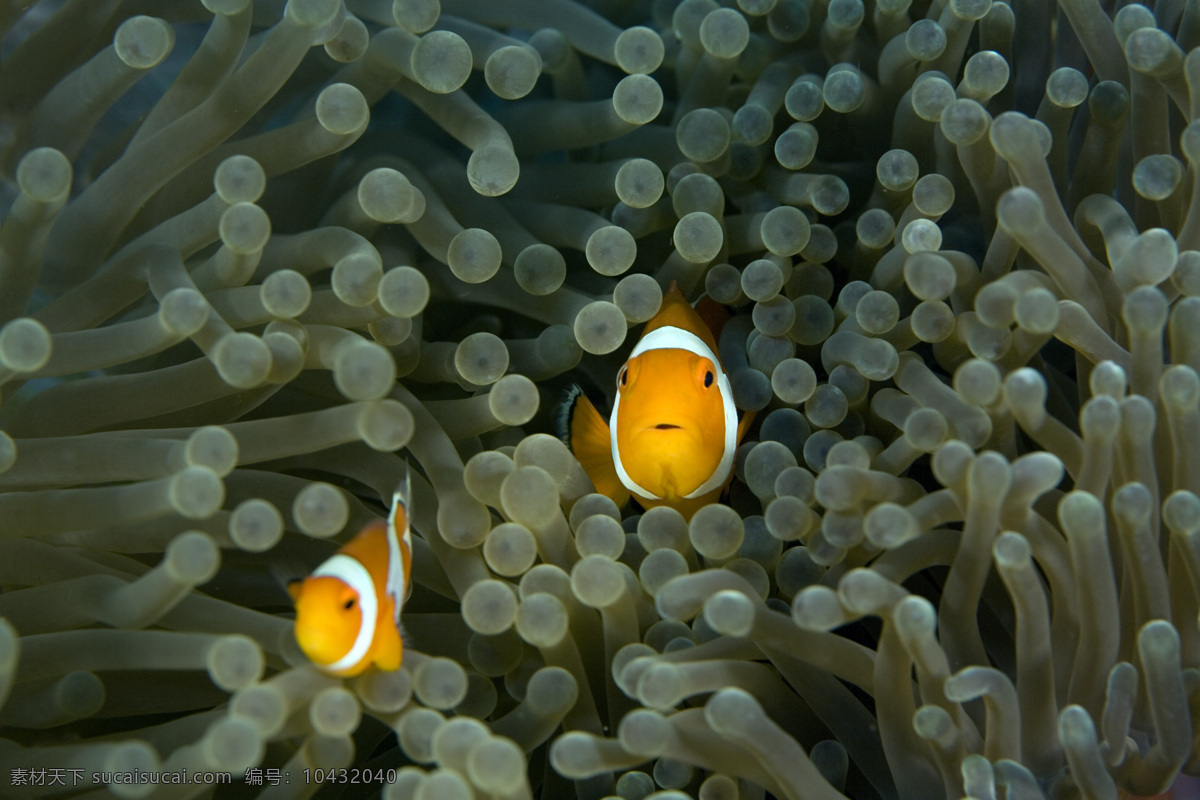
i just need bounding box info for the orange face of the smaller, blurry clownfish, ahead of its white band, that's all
[293,576,362,674]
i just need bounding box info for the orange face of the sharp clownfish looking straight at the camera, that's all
[613,349,726,498]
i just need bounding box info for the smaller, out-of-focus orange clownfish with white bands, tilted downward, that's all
[288,483,413,676]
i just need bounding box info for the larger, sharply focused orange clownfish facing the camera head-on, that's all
[560,282,752,518]
